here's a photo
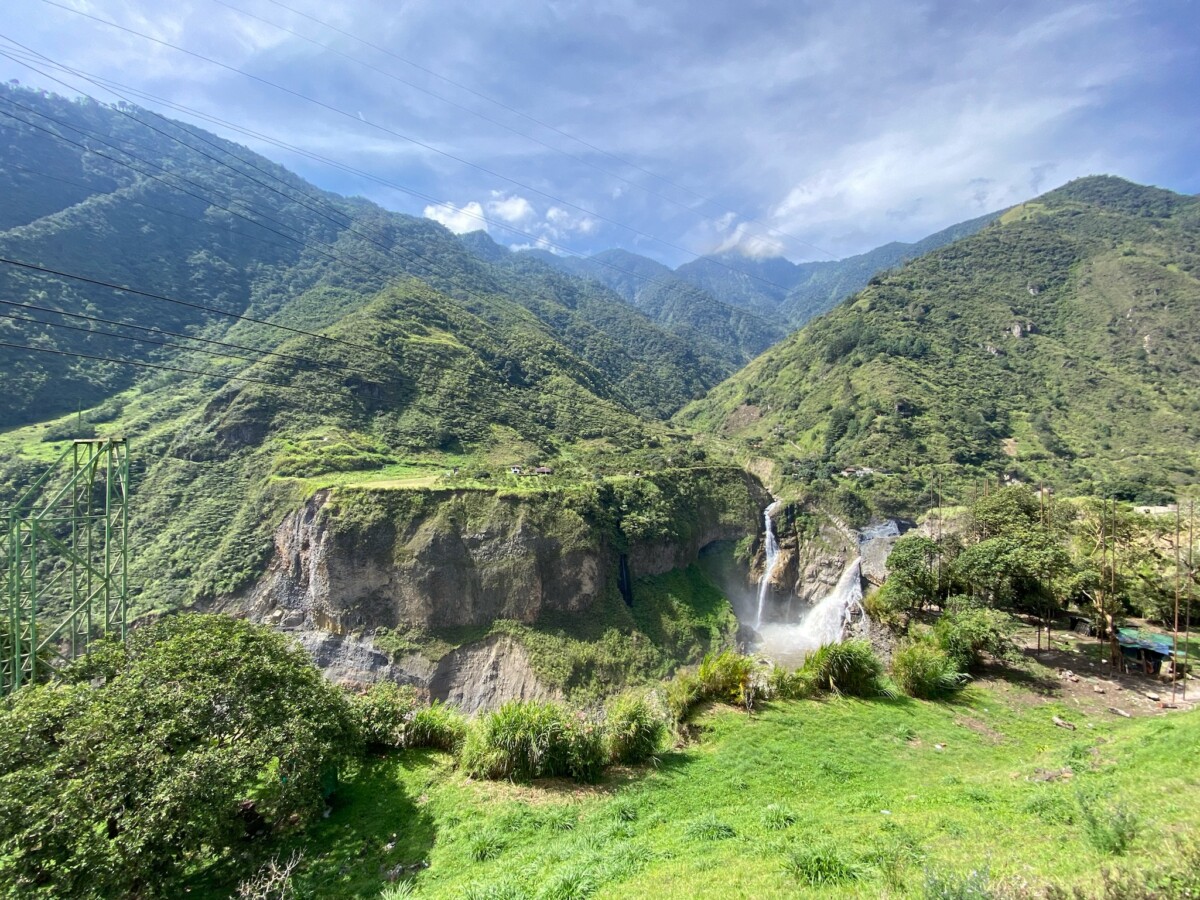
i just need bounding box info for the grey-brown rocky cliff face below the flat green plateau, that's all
[220,472,766,712]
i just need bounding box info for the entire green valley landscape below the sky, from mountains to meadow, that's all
[0,72,1200,900]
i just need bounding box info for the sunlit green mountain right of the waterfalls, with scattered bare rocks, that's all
[677,176,1200,508]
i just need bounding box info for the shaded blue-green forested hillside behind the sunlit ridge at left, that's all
[0,85,734,425]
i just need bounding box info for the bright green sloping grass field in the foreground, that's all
[193,665,1200,900]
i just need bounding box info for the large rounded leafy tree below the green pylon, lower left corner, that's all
[0,614,358,898]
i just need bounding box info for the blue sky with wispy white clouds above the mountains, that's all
[0,0,1200,264]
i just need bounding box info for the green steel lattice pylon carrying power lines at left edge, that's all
[0,438,130,694]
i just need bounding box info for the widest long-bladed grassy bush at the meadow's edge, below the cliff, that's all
[461,700,606,781]
